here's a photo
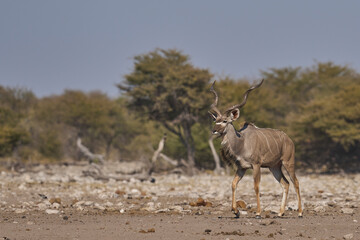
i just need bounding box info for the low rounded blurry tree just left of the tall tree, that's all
[34,90,139,158]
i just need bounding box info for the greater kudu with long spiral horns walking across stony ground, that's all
[209,80,302,218]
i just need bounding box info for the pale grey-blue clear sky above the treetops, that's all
[0,0,360,97]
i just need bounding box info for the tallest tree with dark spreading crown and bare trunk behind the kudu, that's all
[119,49,212,170]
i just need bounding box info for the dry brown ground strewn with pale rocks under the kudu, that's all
[0,163,360,240]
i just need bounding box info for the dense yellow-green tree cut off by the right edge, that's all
[288,62,360,168]
